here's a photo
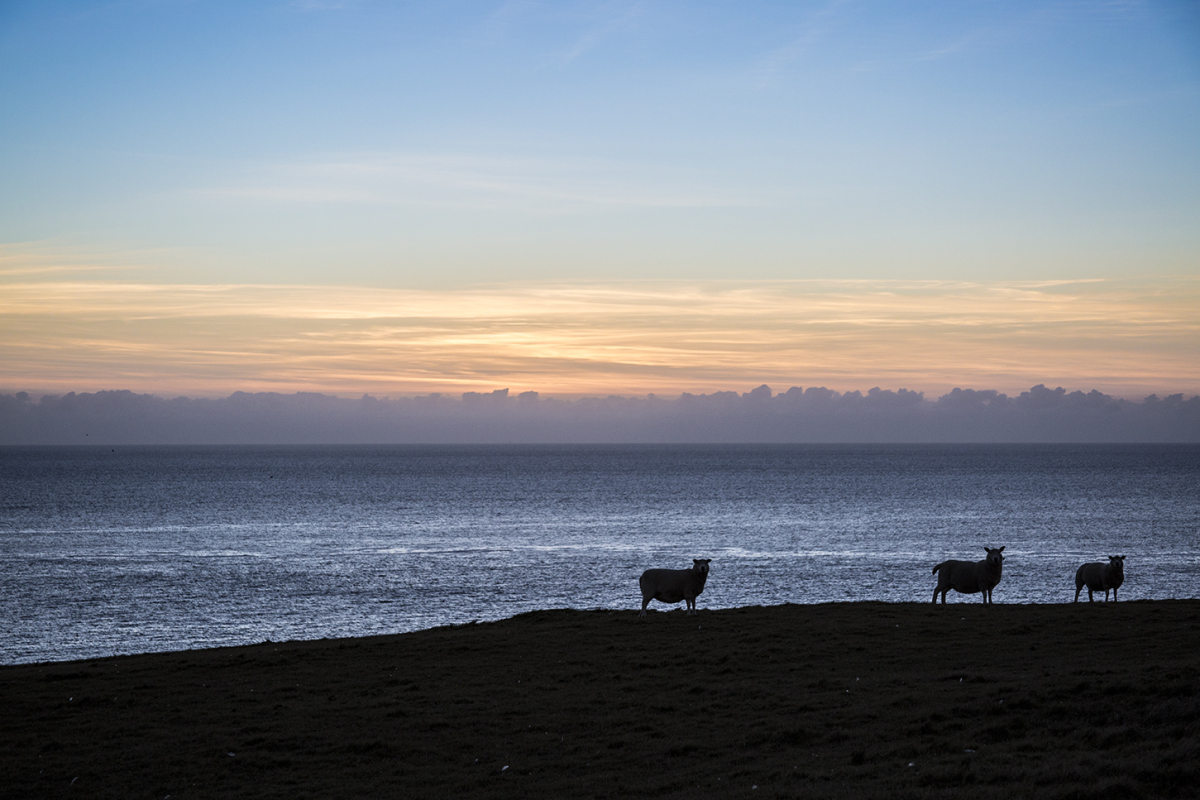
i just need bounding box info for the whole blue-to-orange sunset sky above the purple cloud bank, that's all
[0,0,1200,398]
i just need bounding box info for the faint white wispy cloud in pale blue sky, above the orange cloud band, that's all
[200,154,748,213]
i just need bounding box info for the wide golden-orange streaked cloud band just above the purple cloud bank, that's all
[0,278,1200,397]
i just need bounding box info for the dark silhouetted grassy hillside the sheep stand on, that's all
[0,601,1200,799]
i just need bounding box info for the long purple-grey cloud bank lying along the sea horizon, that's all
[0,385,1200,445]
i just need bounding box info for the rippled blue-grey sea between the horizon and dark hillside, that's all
[0,445,1200,663]
